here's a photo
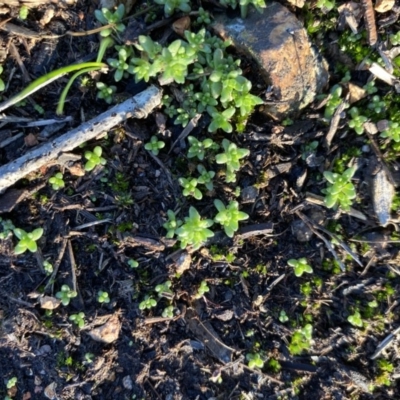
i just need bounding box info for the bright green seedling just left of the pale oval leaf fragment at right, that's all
[322,167,356,211]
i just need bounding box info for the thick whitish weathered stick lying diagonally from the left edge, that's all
[0,86,162,193]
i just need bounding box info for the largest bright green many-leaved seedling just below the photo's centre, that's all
[176,207,214,250]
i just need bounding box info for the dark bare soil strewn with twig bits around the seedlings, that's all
[0,1,400,400]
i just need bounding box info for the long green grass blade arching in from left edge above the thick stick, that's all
[0,62,107,112]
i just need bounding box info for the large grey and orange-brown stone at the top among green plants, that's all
[212,3,329,120]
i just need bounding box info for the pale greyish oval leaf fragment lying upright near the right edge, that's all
[372,168,394,226]
